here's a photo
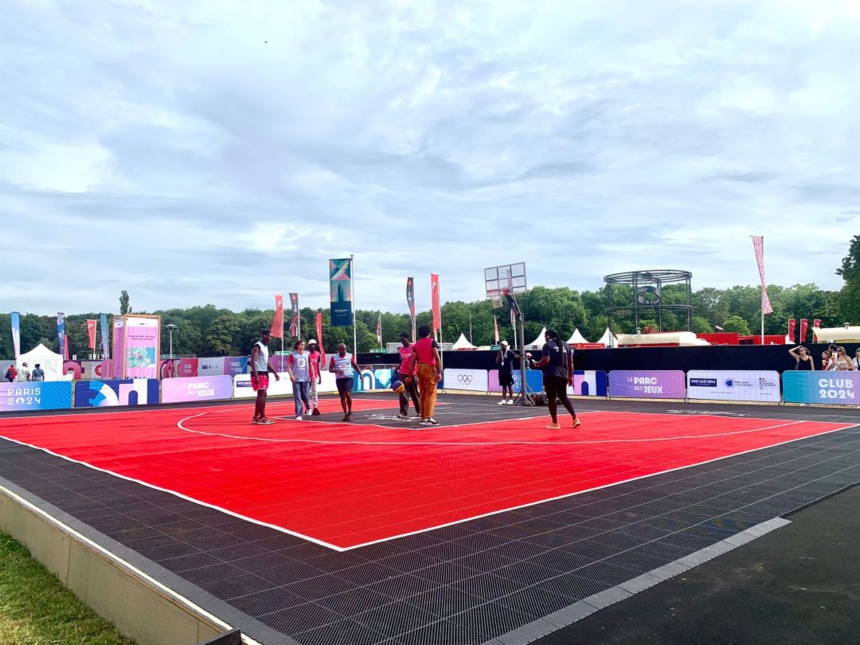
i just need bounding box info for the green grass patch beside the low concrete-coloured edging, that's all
[0,533,134,645]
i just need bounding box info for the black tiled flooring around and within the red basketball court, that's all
[0,395,860,645]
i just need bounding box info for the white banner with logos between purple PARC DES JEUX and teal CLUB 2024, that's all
[687,370,780,403]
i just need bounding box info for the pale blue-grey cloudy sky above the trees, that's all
[0,0,860,314]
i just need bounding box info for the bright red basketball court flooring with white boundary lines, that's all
[0,398,847,550]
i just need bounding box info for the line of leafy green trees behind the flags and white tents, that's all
[0,235,860,359]
